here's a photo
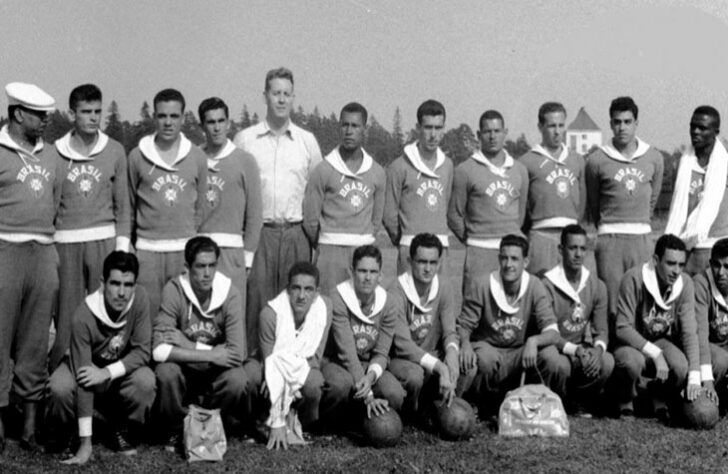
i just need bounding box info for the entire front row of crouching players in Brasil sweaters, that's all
[48,225,728,462]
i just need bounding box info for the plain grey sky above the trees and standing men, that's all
[0,0,728,151]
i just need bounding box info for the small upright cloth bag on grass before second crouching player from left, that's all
[184,405,227,462]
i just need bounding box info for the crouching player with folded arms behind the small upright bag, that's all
[152,237,261,451]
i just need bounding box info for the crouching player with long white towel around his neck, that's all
[260,262,331,449]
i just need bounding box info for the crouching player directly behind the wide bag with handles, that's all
[457,234,569,414]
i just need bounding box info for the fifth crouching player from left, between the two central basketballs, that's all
[389,234,460,420]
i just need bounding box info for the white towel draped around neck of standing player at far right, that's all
[665,140,728,248]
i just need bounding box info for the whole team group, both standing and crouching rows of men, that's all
[0,68,728,463]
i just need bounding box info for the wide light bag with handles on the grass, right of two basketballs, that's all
[498,372,569,436]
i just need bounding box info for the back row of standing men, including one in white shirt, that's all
[0,68,728,458]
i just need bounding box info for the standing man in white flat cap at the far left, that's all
[0,82,59,451]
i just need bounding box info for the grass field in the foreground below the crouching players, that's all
[0,418,728,474]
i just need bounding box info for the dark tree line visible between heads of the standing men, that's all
[0,101,682,212]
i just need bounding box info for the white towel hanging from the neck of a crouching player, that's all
[265,290,326,428]
